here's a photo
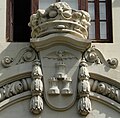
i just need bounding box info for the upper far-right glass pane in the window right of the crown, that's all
[99,3,106,20]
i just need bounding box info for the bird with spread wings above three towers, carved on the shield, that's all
[44,50,75,95]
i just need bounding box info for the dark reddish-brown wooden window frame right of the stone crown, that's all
[87,0,113,43]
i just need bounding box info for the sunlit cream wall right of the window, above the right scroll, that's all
[93,0,120,59]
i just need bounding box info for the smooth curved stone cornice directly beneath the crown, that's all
[30,33,91,52]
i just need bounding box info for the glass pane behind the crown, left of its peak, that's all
[39,0,56,9]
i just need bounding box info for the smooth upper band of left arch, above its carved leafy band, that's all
[0,62,32,87]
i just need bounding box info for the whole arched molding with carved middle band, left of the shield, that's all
[0,62,32,111]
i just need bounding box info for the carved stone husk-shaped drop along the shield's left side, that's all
[30,60,43,114]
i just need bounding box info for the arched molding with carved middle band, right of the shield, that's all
[89,73,120,109]
